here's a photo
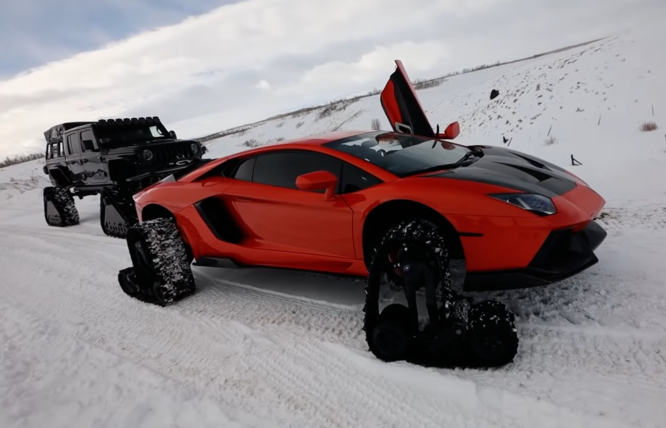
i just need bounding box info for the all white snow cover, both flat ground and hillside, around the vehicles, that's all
[0,21,666,428]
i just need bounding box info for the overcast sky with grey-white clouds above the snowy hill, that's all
[0,0,666,158]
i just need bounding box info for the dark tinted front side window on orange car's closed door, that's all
[252,151,342,193]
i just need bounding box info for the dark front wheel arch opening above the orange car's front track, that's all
[363,199,465,265]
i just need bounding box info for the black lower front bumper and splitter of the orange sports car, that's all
[464,221,607,291]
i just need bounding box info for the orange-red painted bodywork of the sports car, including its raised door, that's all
[134,62,605,290]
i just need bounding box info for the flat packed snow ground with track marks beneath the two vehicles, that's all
[0,171,666,427]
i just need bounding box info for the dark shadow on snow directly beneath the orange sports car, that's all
[189,261,617,332]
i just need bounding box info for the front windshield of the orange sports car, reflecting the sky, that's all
[324,133,470,177]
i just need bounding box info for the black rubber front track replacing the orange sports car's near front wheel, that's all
[363,220,518,368]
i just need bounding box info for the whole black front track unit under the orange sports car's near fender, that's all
[364,220,518,367]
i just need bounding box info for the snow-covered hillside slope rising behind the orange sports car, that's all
[208,21,666,206]
